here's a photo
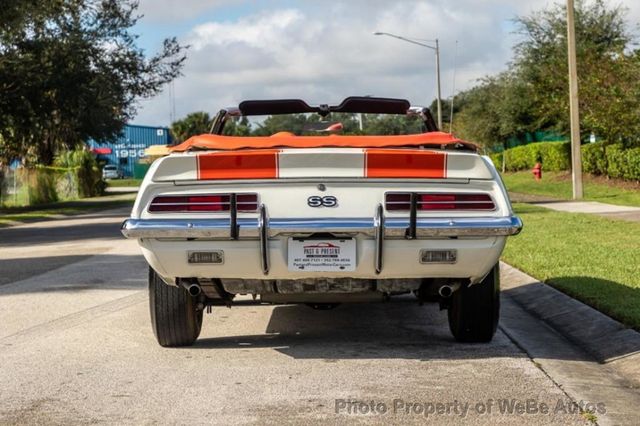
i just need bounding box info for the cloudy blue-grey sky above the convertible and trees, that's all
[133,0,640,126]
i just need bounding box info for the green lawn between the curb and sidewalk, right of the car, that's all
[503,204,640,331]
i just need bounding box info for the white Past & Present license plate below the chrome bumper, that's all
[288,238,356,272]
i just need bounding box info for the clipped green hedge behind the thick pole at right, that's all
[490,142,640,181]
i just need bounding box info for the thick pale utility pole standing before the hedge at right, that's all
[567,0,583,200]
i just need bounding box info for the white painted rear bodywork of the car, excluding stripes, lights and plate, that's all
[123,148,521,290]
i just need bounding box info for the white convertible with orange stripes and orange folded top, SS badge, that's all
[122,97,522,346]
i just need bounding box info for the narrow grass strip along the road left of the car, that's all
[0,193,136,227]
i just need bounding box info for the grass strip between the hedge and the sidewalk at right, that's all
[502,171,640,206]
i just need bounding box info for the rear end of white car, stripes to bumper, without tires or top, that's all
[123,148,521,301]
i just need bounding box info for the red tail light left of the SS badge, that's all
[149,194,258,213]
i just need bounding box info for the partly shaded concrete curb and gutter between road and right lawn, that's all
[500,263,640,425]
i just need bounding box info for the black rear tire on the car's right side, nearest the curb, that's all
[449,263,500,343]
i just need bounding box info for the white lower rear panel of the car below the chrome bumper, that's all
[141,237,506,282]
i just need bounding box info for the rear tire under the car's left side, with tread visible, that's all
[149,268,202,347]
